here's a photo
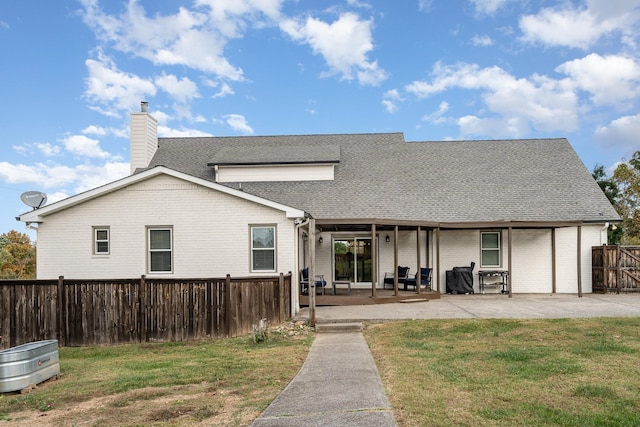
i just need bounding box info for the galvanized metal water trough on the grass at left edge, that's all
[0,340,60,393]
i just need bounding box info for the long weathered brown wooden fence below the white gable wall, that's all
[0,273,291,349]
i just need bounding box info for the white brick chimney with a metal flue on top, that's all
[129,101,158,174]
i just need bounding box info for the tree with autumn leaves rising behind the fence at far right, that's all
[612,150,640,245]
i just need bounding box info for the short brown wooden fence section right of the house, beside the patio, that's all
[591,245,640,293]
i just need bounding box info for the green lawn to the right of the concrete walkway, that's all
[365,318,640,427]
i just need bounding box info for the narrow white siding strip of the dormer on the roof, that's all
[216,165,334,182]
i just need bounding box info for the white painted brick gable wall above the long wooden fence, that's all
[38,176,296,279]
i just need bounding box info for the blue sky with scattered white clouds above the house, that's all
[0,0,640,237]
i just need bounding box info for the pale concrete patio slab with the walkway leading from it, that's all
[252,294,640,427]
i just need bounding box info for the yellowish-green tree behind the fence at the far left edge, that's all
[0,230,36,279]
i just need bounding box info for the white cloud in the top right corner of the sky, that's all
[520,0,640,49]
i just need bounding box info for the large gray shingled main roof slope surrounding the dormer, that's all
[145,133,619,223]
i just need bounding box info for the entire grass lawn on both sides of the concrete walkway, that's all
[0,318,640,427]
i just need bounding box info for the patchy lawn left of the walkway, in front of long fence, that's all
[0,324,312,427]
